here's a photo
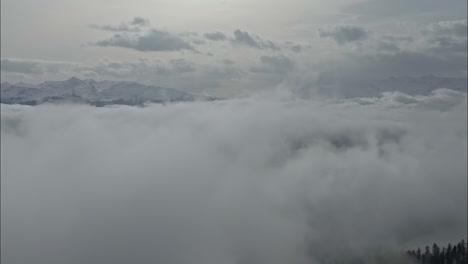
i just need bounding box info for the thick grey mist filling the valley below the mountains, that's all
[1,89,467,264]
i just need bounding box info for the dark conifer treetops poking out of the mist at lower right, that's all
[406,240,468,264]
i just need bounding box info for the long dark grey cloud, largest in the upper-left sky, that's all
[94,29,194,52]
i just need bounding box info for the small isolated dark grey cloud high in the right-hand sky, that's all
[317,25,369,45]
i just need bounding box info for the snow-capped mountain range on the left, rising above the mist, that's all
[0,77,215,106]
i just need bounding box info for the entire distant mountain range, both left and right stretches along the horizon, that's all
[0,75,467,106]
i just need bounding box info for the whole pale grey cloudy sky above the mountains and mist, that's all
[1,0,467,97]
